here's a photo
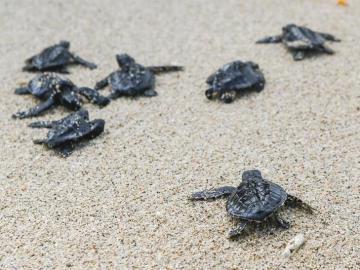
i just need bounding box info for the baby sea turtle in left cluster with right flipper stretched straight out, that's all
[95,54,183,99]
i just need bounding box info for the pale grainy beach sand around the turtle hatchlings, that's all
[0,0,360,269]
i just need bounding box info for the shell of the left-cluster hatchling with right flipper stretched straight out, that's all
[109,63,155,96]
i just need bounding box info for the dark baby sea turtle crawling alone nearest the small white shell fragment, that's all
[190,170,313,238]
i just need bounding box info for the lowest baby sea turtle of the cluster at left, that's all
[29,109,105,157]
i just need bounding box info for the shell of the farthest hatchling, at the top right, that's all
[282,24,326,50]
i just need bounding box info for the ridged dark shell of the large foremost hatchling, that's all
[226,173,287,222]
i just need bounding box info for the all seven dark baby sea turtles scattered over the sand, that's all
[13,24,340,238]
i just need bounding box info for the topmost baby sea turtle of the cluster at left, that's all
[23,41,97,73]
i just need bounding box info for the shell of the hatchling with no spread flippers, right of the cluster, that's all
[206,60,265,92]
